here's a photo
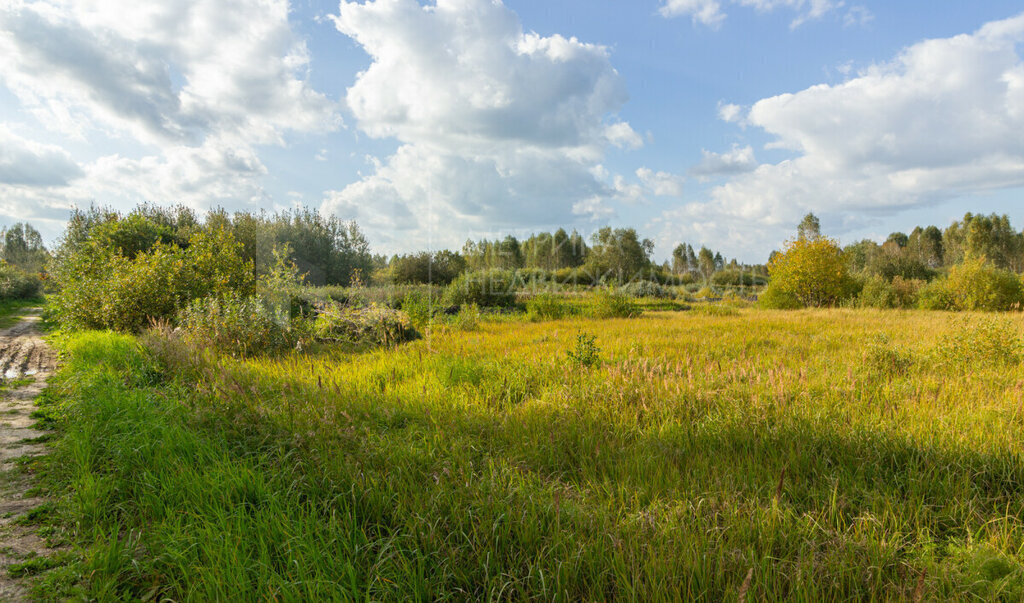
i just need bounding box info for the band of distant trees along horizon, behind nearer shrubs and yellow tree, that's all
[0,205,1024,287]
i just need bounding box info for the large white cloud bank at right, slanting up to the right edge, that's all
[663,14,1024,260]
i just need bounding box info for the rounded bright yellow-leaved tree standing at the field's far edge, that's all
[761,235,855,308]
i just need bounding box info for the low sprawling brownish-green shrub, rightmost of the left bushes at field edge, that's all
[313,303,419,346]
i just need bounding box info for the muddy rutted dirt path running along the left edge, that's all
[0,313,56,601]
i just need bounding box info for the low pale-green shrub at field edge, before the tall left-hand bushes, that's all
[178,293,297,356]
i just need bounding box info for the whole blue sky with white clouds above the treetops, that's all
[0,0,1024,263]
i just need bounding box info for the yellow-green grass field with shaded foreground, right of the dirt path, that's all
[28,308,1024,601]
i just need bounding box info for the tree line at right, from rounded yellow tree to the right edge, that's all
[762,213,1024,310]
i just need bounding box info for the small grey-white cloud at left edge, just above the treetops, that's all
[0,124,82,187]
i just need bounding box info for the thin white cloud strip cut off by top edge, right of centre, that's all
[658,0,873,29]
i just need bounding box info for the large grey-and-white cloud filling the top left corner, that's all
[0,0,339,144]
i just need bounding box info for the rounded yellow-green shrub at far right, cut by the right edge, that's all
[919,259,1024,311]
